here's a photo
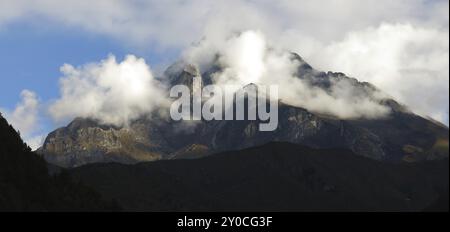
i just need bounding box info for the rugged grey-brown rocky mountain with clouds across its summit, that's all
[38,54,449,167]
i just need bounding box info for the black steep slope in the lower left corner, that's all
[0,115,119,211]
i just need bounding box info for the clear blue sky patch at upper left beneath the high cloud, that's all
[0,22,176,109]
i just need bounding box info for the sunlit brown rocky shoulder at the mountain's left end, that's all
[37,118,168,167]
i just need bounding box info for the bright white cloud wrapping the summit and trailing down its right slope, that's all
[185,31,390,119]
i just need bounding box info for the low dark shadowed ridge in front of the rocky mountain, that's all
[70,142,449,212]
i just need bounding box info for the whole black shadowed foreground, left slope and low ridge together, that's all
[0,111,449,211]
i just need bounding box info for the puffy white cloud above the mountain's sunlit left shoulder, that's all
[49,55,167,126]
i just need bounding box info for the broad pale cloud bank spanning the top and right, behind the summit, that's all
[0,0,449,124]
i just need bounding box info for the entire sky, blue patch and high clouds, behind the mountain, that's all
[0,0,449,149]
